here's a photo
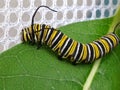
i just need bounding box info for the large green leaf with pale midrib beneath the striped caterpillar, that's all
[0,5,120,90]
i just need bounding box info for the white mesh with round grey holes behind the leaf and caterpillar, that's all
[0,0,120,53]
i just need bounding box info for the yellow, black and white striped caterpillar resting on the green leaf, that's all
[22,6,120,64]
